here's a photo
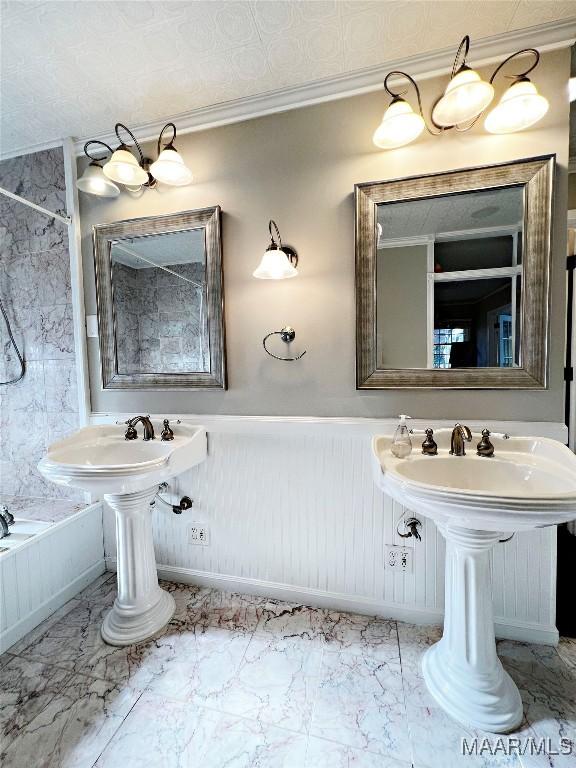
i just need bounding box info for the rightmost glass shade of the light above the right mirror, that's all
[484,80,549,133]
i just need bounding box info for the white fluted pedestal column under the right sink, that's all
[422,525,523,733]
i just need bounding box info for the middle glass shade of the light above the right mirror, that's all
[432,69,494,128]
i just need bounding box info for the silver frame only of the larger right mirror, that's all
[354,155,556,389]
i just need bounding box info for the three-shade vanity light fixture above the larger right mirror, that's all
[373,35,548,149]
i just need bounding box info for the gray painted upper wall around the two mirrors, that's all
[81,50,569,421]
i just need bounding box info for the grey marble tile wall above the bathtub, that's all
[0,147,78,498]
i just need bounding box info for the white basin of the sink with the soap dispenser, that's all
[372,429,576,532]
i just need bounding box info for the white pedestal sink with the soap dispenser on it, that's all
[372,430,576,733]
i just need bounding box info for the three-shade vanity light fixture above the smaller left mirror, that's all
[77,123,192,197]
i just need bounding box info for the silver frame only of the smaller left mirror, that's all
[93,206,226,389]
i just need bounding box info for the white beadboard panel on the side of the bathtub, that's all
[0,503,105,653]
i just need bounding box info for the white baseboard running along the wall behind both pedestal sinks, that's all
[106,557,558,645]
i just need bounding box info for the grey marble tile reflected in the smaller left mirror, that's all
[113,263,209,373]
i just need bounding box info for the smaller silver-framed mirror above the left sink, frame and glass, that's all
[93,206,226,389]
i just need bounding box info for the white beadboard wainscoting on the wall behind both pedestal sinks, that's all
[94,415,566,644]
